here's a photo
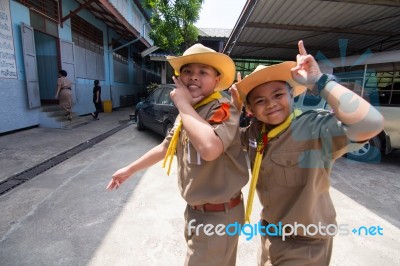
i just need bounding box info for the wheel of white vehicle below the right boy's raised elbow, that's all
[346,136,382,162]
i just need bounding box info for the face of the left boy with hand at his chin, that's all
[180,63,220,98]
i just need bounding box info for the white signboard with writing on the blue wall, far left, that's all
[0,0,18,79]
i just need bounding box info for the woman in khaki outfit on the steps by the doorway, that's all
[55,70,72,121]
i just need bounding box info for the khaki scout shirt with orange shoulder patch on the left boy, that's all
[165,98,248,205]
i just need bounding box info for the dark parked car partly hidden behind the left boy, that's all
[135,84,178,136]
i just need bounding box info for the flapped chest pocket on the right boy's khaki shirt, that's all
[270,151,307,187]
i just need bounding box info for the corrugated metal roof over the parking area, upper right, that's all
[224,0,400,60]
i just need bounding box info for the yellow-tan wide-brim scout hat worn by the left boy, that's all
[167,43,235,91]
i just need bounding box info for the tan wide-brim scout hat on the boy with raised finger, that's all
[236,61,307,100]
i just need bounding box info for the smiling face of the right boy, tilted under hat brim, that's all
[247,81,292,126]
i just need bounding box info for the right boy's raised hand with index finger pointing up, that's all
[292,41,322,89]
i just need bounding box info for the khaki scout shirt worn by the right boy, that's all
[242,111,359,238]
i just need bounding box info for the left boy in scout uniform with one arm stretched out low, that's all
[107,44,248,266]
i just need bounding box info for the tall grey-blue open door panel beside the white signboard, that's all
[21,23,40,109]
